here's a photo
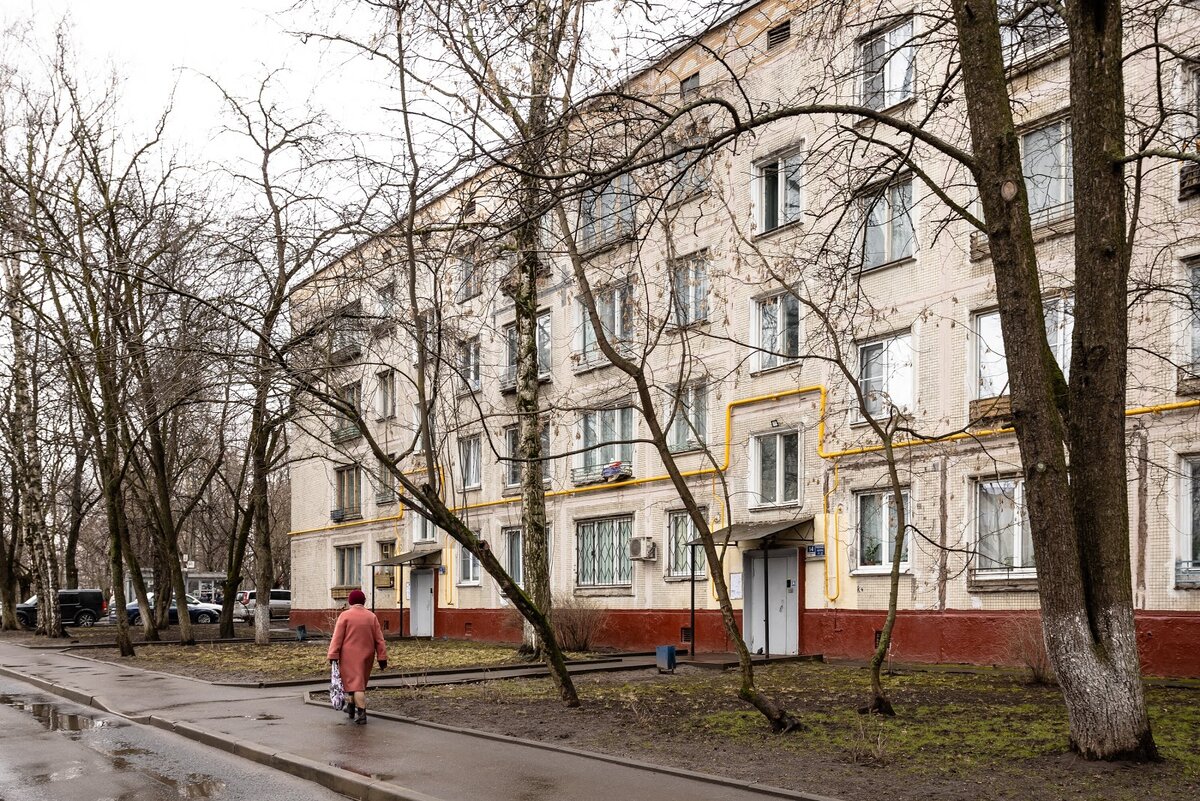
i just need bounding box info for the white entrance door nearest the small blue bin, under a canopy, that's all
[742,548,800,656]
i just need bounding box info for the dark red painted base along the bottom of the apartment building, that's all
[290,609,1200,677]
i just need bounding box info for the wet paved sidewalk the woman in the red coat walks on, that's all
[0,643,835,801]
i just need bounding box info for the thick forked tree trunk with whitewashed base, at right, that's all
[952,0,1157,760]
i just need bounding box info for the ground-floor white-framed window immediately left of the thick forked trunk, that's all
[976,478,1034,573]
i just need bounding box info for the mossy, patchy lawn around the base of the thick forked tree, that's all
[371,663,1200,801]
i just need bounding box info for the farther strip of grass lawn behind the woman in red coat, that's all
[97,640,532,681]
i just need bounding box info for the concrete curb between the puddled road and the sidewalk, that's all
[0,666,443,801]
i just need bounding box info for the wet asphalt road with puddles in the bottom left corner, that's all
[0,677,346,801]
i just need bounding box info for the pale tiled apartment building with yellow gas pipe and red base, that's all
[290,2,1200,675]
